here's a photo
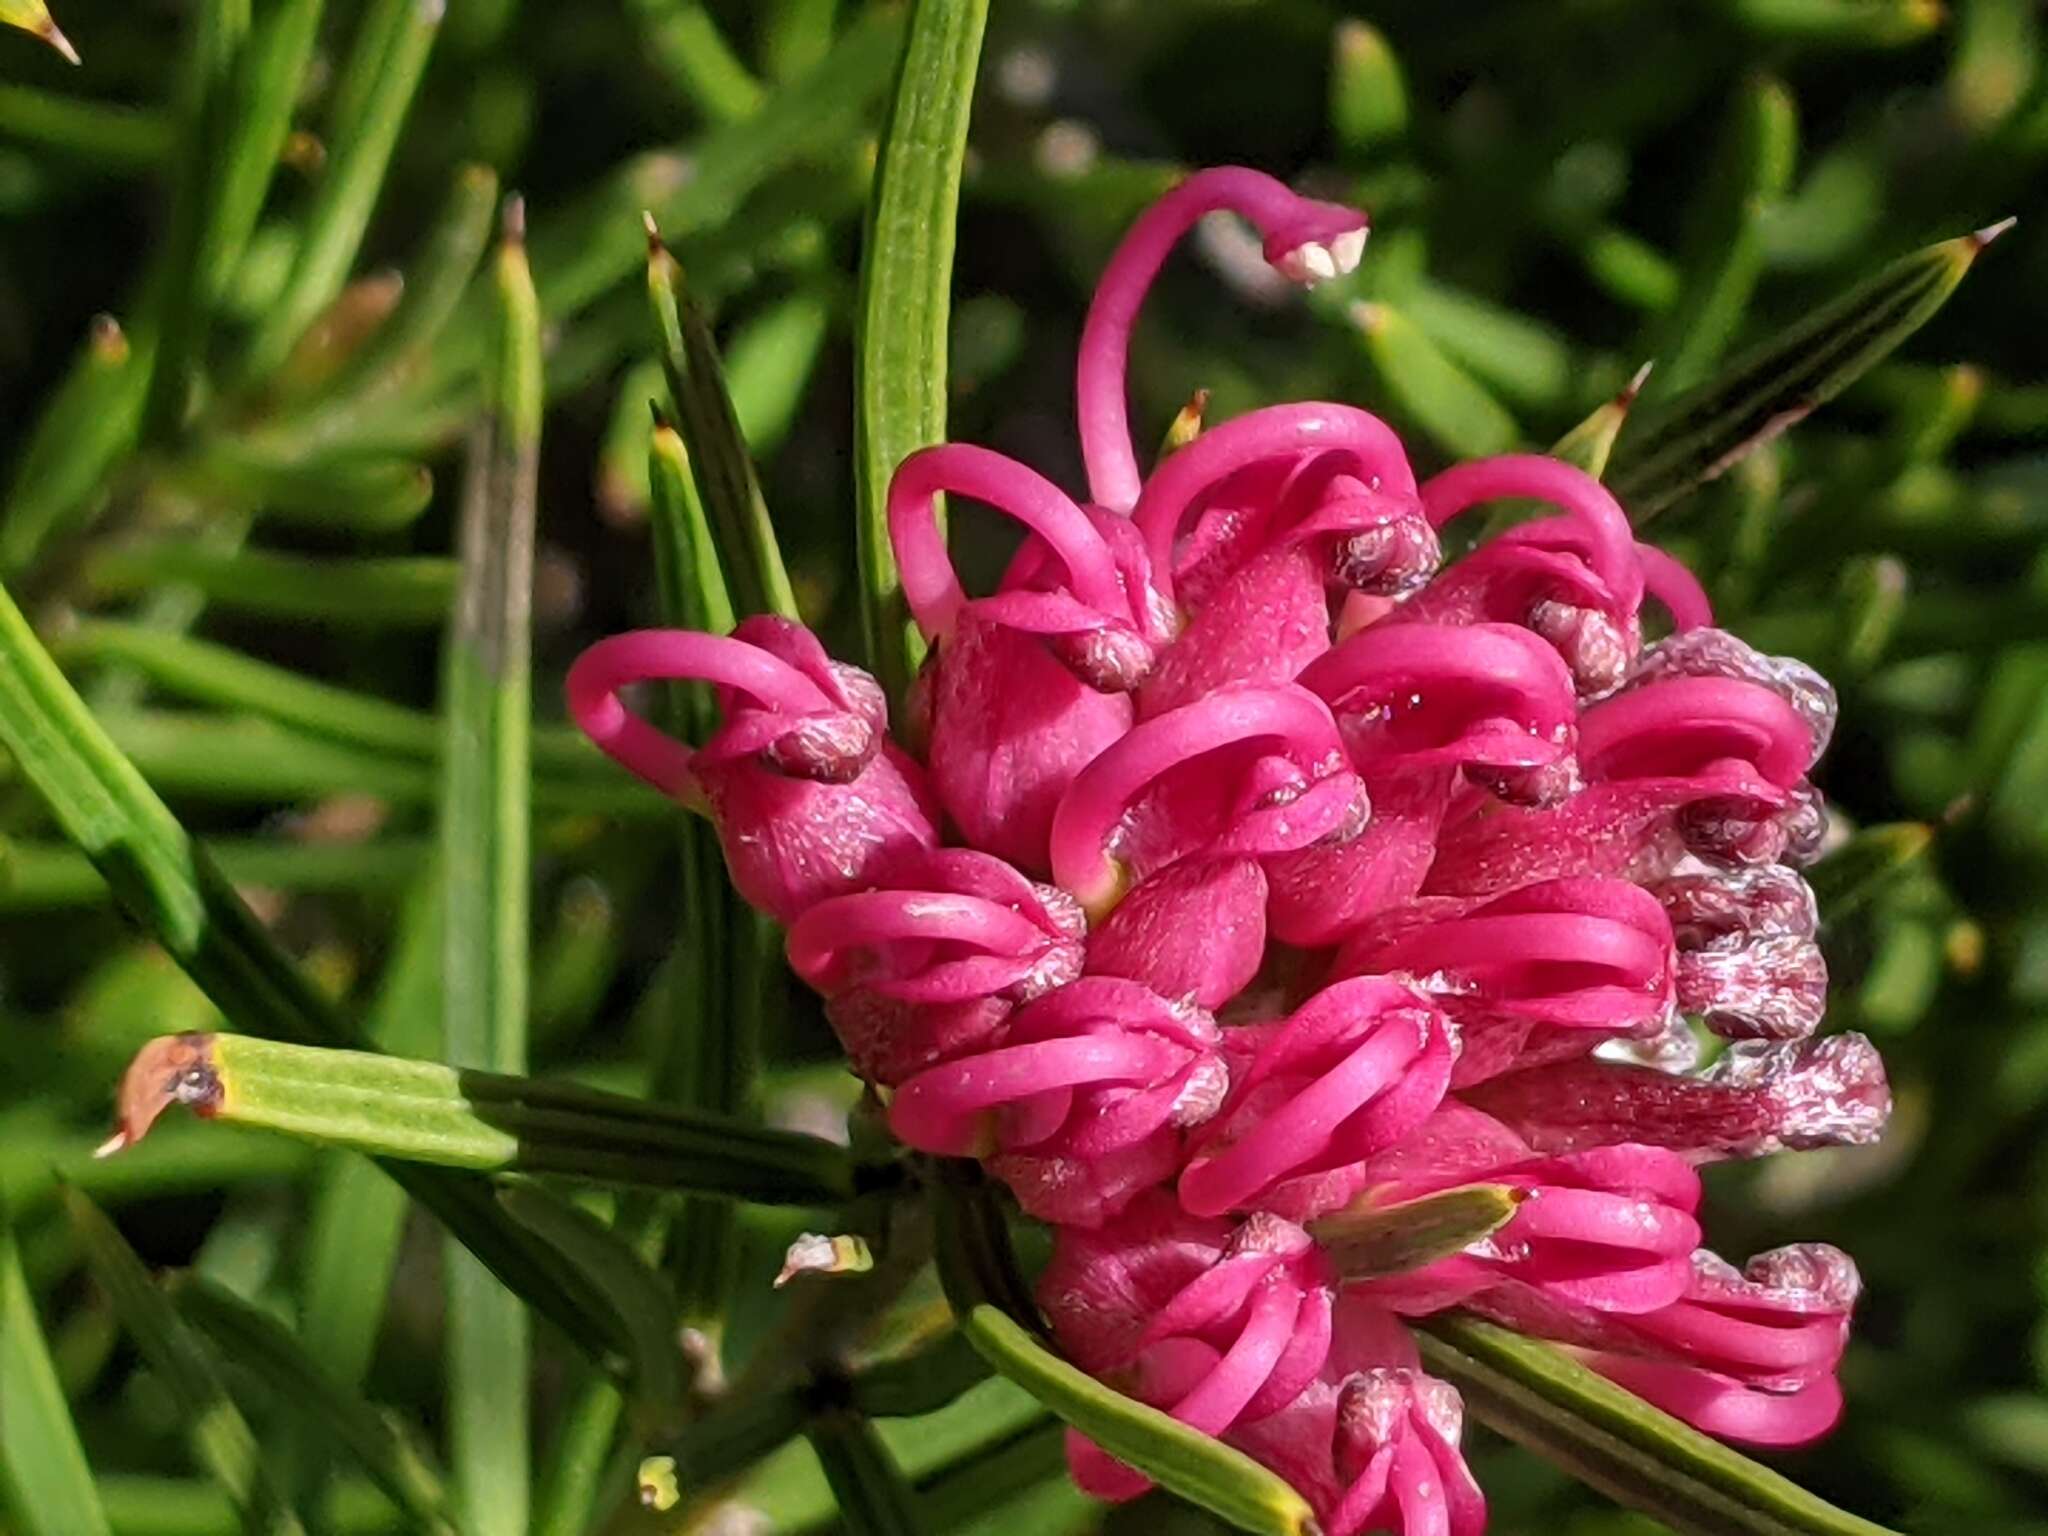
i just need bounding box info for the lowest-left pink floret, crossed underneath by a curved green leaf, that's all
[1038,1192,1331,1499]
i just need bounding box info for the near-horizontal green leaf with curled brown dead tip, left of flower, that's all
[109,1034,856,1204]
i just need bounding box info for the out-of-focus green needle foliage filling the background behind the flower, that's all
[0,0,2048,1536]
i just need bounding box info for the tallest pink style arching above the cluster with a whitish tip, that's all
[1073,166,1368,512]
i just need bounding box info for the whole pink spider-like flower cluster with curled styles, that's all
[569,170,1890,1536]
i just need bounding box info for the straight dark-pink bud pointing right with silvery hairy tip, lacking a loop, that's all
[1460,1034,1892,1161]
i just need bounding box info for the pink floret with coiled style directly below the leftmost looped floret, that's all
[788,848,1085,1085]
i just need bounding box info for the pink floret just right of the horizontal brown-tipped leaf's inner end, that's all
[889,977,1227,1227]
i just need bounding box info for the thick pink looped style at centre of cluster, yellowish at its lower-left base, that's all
[1051,686,1362,918]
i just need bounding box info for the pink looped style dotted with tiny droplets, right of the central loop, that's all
[1300,625,1577,776]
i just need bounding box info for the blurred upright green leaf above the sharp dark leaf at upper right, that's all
[1642,76,1798,393]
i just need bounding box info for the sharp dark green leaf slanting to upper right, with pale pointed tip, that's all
[1608,225,2005,522]
